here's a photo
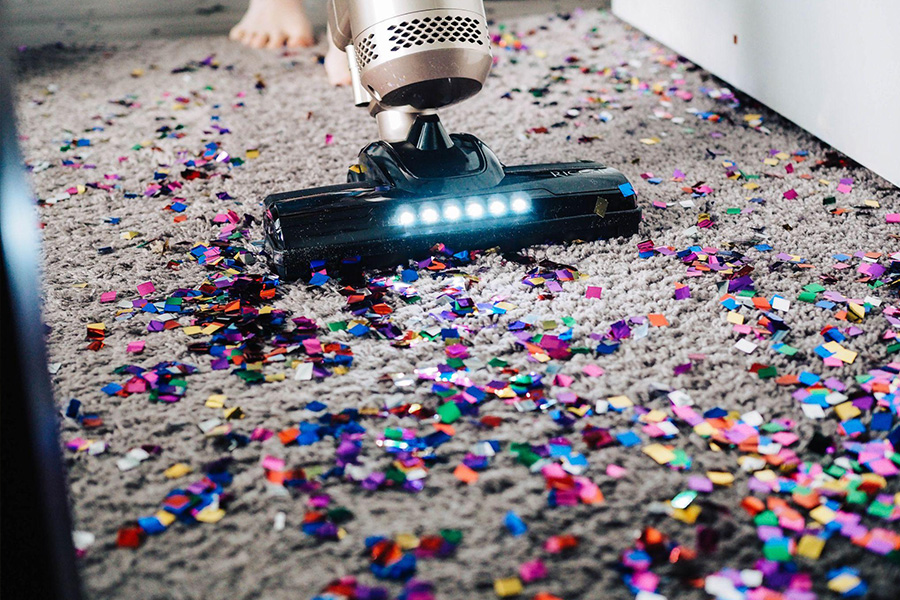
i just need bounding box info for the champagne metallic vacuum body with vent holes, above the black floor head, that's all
[329,0,493,139]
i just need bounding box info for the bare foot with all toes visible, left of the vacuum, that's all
[228,0,314,49]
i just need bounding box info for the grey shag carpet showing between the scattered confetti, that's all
[12,5,900,600]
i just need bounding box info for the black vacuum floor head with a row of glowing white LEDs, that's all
[264,118,641,279]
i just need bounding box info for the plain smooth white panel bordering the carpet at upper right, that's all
[612,0,900,186]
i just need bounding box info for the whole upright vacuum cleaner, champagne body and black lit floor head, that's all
[264,0,641,279]
